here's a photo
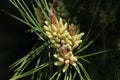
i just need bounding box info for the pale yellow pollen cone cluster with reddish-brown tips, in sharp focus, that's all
[43,11,84,72]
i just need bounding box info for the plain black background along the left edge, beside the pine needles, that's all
[0,0,37,80]
